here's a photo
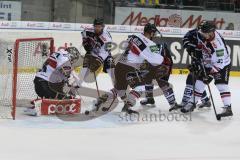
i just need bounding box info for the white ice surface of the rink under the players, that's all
[0,75,240,160]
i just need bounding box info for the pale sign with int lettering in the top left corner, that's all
[0,1,21,21]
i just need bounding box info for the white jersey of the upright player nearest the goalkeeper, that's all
[82,28,112,60]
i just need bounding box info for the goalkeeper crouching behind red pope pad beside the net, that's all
[34,47,80,99]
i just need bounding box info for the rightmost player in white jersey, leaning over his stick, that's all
[181,21,233,117]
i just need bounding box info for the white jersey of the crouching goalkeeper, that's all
[36,50,73,83]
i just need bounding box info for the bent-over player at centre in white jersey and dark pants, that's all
[96,23,180,114]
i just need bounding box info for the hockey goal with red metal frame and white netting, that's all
[0,38,54,119]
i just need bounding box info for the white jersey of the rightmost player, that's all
[197,31,231,71]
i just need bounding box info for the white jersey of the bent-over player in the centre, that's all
[126,34,163,66]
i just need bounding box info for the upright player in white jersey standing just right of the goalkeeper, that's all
[78,18,115,86]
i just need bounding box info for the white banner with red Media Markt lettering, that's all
[115,7,240,30]
